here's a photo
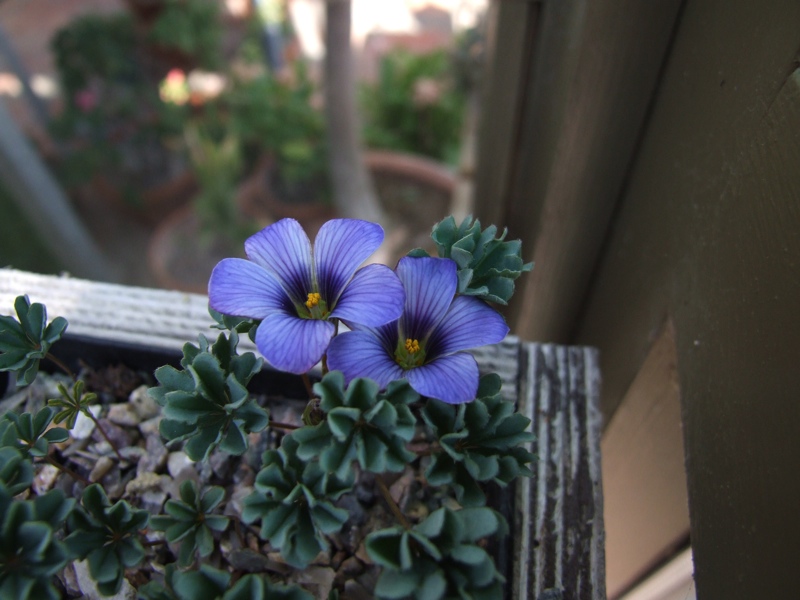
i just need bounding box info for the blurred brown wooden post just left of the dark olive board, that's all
[476,0,682,342]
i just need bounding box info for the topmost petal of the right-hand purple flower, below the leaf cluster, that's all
[397,256,458,342]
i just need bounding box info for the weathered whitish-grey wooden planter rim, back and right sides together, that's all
[0,269,605,600]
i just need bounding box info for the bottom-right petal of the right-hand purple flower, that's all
[405,352,479,404]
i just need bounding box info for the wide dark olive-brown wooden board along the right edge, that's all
[578,0,800,600]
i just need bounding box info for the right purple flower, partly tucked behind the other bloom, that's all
[328,257,508,404]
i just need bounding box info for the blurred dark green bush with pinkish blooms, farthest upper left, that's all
[49,13,188,196]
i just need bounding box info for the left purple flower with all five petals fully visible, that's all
[208,219,404,373]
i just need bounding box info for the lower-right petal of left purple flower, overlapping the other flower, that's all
[331,265,406,327]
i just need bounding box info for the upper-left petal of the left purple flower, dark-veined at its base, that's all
[244,219,313,303]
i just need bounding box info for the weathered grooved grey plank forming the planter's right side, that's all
[513,343,606,600]
